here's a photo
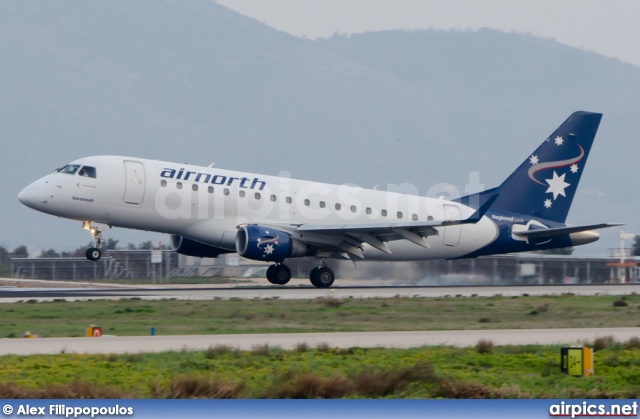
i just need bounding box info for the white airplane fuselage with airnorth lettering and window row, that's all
[20,156,499,260]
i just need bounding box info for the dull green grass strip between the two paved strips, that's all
[0,294,640,338]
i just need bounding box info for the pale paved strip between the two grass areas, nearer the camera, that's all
[0,327,640,355]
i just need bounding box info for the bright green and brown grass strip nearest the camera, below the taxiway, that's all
[0,339,640,398]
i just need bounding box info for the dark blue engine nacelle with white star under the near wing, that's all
[236,224,312,262]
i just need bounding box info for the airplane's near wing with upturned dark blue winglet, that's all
[260,193,498,259]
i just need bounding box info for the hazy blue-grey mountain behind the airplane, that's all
[0,0,640,254]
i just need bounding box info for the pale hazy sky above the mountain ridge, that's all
[218,0,640,66]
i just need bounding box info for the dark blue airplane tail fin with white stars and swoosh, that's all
[462,112,602,223]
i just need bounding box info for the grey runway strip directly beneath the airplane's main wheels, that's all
[0,283,640,303]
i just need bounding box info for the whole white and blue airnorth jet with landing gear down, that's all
[18,112,619,287]
